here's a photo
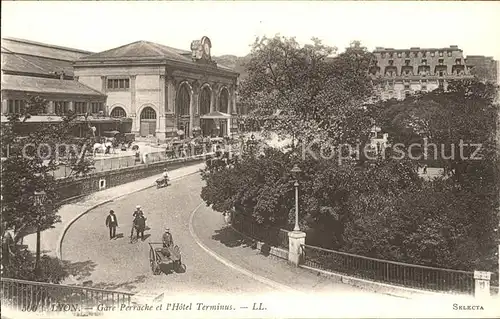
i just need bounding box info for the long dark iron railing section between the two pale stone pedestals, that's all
[301,245,474,294]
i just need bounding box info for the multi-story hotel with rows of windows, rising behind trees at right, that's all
[370,45,473,100]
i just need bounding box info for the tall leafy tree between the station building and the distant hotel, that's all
[240,36,374,144]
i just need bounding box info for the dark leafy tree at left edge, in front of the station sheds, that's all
[2,97,91,280]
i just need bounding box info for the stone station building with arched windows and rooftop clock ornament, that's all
[74,37,238,140]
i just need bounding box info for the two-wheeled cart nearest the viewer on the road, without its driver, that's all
[149,243,182,275]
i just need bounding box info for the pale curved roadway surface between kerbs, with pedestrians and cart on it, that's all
[62,175,273,294]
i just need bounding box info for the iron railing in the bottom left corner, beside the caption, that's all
[0,278,134,312]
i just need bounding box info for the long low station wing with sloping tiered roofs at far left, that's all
[1,38,130,136]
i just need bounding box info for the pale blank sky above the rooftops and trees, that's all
[1,1,500,60]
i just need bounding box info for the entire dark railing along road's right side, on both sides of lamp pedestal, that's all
[232,212,498,294]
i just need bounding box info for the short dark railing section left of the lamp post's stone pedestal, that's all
[231,213,288,250]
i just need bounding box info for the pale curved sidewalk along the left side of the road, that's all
[23,163,205,257]
